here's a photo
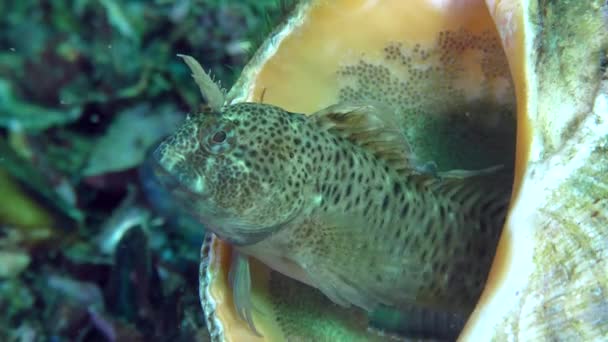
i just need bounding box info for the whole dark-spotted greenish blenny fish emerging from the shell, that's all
[154,56,512,336]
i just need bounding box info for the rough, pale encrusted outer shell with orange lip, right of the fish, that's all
[462,1,608,341]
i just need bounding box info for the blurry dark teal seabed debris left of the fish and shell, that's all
[0,0,288,341]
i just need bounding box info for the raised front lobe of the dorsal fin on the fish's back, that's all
[311,103,417,173]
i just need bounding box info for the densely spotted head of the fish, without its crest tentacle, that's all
[154,103,306,245]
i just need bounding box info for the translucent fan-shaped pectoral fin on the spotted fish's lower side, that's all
[293,213,416,312]
